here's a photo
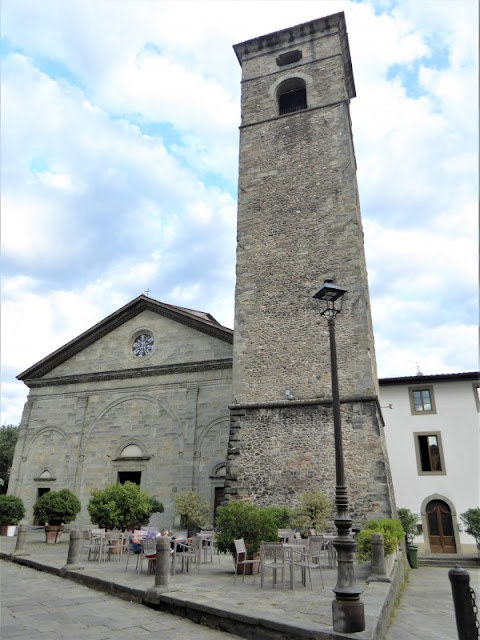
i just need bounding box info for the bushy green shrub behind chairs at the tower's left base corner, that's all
[215,500,278,573]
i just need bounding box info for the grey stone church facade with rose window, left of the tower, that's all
[9,296,233,527]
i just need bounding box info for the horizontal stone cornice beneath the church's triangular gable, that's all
[23,358,232,389]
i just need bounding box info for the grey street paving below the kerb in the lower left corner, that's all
[0,561,238,640]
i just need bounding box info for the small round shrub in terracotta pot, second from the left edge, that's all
[33,489,82,543]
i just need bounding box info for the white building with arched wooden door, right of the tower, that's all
[380,372,480,553]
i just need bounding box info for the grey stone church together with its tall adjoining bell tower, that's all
[10,13,395,526]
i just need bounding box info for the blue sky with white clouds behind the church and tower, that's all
[1,0,478,424]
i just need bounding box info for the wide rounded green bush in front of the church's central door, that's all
[87,482,153,531]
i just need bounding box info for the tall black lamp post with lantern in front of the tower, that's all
[313,279,365,633]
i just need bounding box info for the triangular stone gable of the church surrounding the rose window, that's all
[17,295,233,386]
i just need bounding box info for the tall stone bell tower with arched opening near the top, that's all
[226,13,394,526]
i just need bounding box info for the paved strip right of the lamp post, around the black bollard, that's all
[386,567,480,640]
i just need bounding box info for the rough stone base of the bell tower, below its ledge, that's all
[226,401,394,527]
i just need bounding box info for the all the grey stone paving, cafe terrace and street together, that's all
[0,529,480,640]
